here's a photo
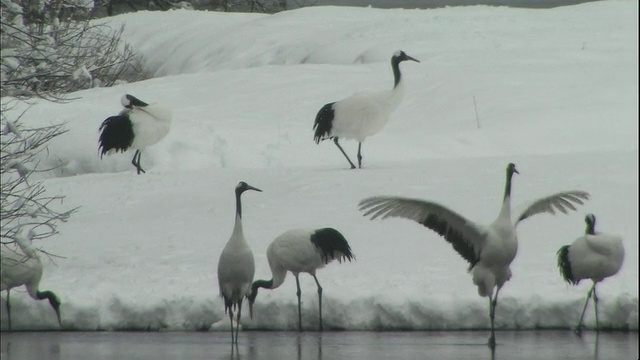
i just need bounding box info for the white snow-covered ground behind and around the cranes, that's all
[1,1,638,331]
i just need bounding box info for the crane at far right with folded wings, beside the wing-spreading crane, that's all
[557,214,624,334]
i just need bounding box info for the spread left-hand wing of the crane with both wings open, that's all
[359,196,487,269]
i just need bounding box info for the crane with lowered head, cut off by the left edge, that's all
[0,232,62,331]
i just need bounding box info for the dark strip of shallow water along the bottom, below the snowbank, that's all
[1,331,638,360]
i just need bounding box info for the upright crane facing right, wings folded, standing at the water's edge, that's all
[218,181,262,343]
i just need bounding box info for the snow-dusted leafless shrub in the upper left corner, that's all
[0,0,145,98]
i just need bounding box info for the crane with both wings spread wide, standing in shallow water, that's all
[360,163,589,347]
